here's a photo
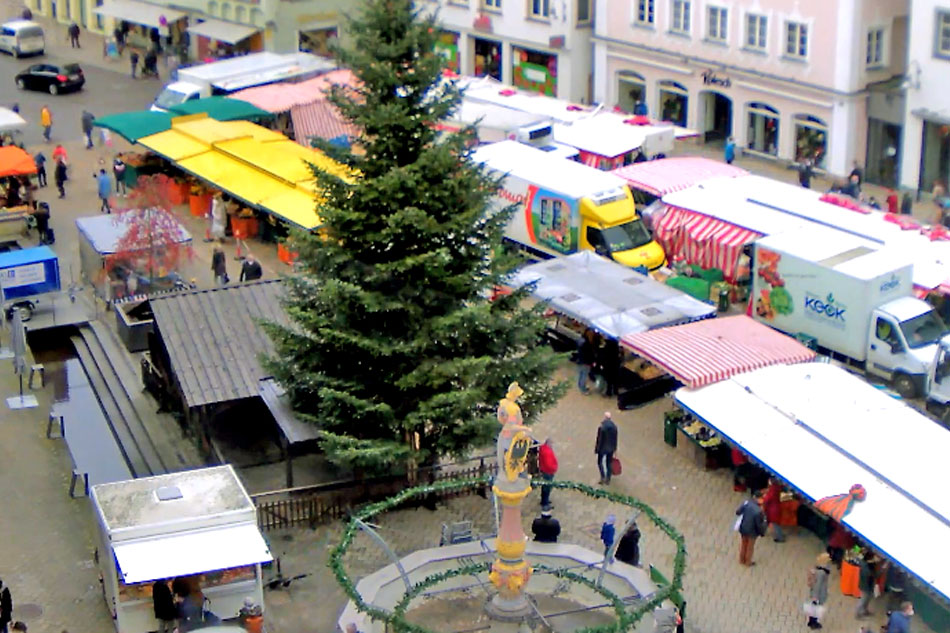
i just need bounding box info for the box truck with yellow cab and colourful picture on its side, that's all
[473,141,666,270]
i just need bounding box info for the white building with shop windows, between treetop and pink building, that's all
[417,0,594,103]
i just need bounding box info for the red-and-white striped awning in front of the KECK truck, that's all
[621,315,815,389]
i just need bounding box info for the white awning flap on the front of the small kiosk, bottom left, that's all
[113,524,273,584]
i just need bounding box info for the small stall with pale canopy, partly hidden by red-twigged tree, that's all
[76,209,191,300]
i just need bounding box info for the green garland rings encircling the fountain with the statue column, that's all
[329,476,686,633]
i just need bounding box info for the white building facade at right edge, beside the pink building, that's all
[900,0,950,192]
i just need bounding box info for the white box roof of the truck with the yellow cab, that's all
[472,141,627,198]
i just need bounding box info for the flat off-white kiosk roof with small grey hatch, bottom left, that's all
[92,465,254,531]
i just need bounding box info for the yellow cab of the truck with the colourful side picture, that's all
[580,187,666,270]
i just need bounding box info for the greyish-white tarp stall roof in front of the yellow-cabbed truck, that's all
[512,251,716,339]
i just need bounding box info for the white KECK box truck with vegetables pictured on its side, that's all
[752,227,950,398]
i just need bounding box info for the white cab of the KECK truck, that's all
[865,297,950,398]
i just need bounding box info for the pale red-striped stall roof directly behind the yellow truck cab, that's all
[612,156,749,197]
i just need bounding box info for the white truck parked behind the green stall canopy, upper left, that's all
[151,52,336,112]
